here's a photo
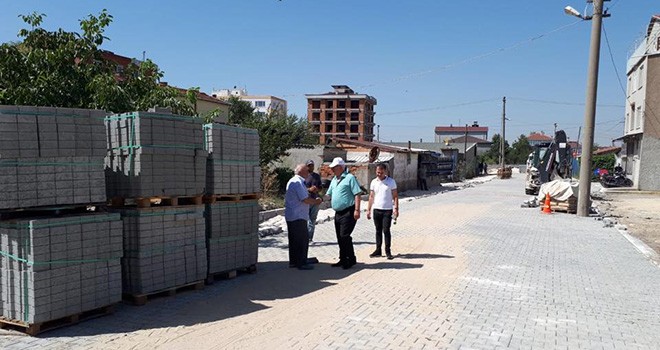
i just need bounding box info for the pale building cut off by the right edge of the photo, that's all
[617,15,660,191]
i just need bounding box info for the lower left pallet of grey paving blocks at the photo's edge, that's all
[0,213,122,335]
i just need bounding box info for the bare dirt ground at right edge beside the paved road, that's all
[598,191,660,262]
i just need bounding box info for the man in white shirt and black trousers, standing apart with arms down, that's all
[367,163,399,260]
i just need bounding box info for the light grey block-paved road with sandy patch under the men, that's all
[0,176,660,349]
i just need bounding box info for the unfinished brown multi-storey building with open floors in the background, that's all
[305,85,377,144]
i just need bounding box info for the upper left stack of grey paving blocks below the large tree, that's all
[0,106,106,209]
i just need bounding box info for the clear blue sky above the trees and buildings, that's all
[0,0,660,145]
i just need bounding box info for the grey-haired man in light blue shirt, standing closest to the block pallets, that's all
[284,164,323,270]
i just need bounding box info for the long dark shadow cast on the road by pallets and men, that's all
[34,261,423,339]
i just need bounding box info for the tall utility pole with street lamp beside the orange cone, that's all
[564,0,610,216]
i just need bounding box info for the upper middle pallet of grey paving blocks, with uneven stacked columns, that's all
[105,112,207,204]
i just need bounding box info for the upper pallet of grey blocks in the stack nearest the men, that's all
[204,123,261,195]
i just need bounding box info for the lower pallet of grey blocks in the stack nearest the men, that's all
[206,200,259,283]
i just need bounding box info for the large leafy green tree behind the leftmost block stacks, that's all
[0,10,194,115]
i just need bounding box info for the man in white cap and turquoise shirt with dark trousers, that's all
[326,157,362,269]
